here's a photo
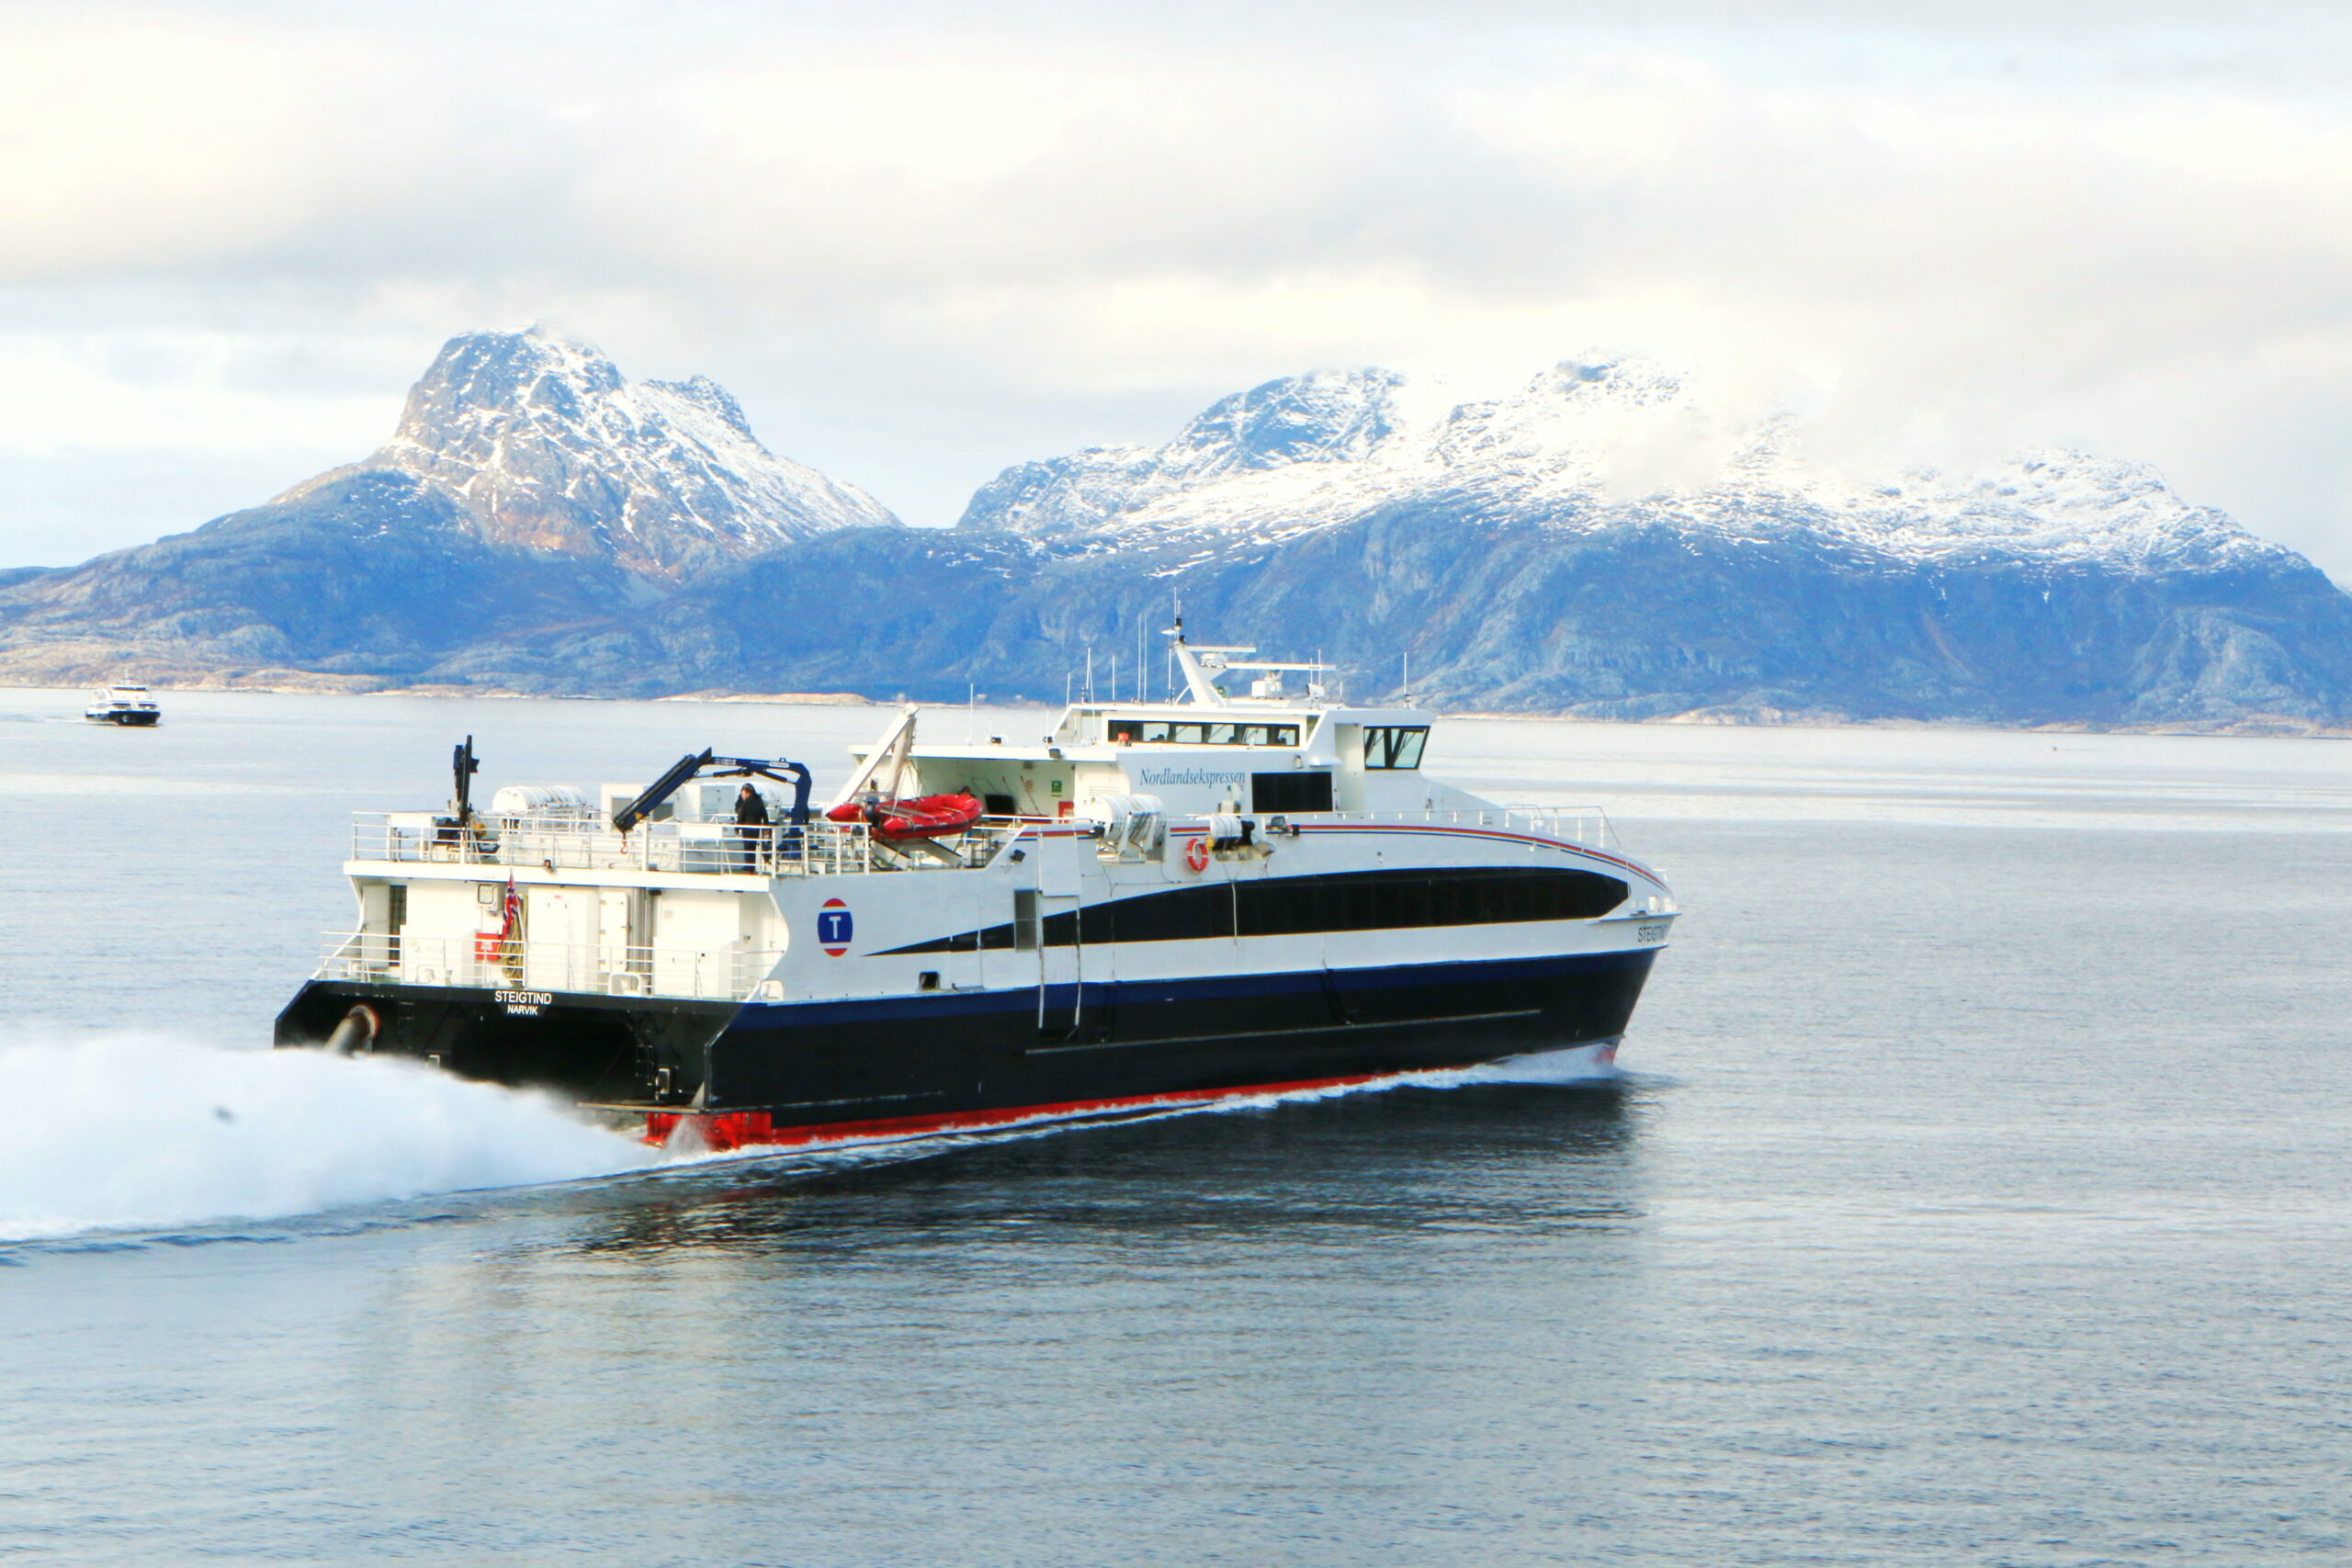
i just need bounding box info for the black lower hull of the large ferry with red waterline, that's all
[277,947,1656,1138]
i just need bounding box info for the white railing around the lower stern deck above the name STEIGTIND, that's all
[315,931,783,1001]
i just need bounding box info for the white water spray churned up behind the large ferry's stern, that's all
[0,1032,661,1241]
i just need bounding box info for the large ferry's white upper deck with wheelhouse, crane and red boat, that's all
[348,635,1611,886]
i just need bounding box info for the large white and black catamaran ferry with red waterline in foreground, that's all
[276,627,1677,1149]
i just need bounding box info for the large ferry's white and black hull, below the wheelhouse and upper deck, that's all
[277,823,1675,1147]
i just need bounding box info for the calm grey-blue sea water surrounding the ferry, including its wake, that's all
[0,691,2352,1565]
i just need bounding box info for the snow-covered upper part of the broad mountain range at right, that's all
[965,360,2290,569]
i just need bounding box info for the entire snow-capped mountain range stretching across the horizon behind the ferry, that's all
[0,333,2352,728]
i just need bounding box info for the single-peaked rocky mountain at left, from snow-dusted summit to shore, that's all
[0,329,900,689]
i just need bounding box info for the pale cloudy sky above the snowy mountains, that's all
[0,0,2352,583]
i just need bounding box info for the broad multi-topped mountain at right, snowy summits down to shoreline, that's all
[962,365,2352,724]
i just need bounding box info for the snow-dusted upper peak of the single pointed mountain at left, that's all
[273,327,896,579]
